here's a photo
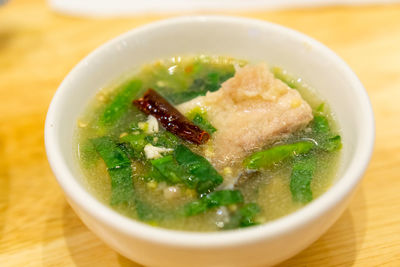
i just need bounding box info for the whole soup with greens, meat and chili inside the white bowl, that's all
[75,55,341,231]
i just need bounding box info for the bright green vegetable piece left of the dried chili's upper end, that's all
[99,80,142,126]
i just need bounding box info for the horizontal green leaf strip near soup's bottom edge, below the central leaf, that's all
[184,190,243,216]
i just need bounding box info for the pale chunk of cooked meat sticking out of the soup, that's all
[177,64,313,186]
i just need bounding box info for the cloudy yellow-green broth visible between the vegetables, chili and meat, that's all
[75,55,340,231]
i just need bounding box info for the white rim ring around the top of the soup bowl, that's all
[44,15,375,248]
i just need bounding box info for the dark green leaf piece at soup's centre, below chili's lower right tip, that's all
[174,145,223,193]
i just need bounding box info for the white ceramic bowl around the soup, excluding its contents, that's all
[45,16,375,266]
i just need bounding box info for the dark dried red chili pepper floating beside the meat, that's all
[133,89,210,145]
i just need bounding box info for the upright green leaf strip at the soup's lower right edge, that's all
[290,156,316,203]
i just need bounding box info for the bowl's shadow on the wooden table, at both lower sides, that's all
[55,185,367,267]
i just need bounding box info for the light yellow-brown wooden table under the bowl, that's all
[0,0,400,267]
